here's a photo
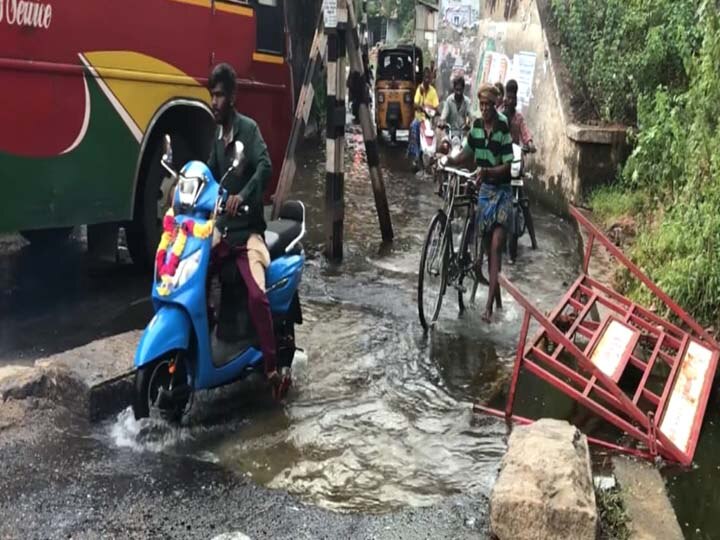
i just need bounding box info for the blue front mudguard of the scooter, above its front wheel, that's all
[135,305,192,367]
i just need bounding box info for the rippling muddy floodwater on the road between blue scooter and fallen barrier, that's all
[111,131,578,512]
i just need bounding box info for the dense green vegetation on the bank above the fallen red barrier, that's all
[552,0,720,325]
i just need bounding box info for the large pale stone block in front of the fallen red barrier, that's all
[490,419,597,540]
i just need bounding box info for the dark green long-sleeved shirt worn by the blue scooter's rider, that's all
[208,112,272,245]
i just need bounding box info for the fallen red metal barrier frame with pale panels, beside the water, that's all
[474,207,720,465]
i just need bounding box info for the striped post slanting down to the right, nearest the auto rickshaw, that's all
[345,0,393,242]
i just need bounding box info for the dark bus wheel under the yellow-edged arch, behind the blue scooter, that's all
[126,135,190,270]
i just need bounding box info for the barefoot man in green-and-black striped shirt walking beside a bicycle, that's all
[438,84,513,323]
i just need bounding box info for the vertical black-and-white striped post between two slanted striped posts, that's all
[324,0,348,262]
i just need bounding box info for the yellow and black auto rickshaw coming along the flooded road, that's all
[375,45,423,142]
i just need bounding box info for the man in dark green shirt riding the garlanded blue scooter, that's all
[208,64,282,394]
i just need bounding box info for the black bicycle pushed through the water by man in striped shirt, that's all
[418,163,485,331]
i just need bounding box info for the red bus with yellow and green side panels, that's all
[0,0,293,263]
